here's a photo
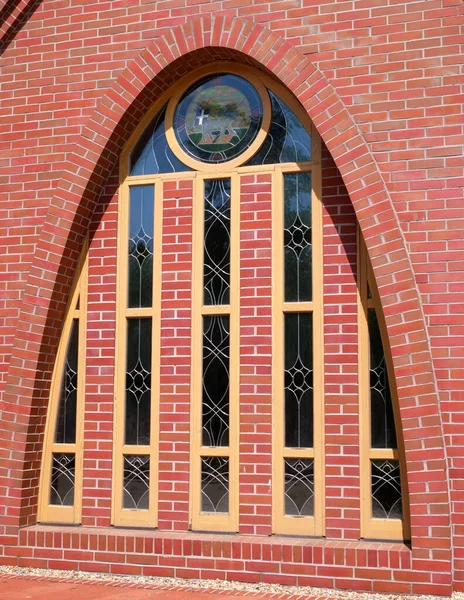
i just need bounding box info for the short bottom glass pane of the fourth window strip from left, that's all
[285,458,314,517]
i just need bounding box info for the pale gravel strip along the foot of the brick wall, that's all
[0,566,458,600]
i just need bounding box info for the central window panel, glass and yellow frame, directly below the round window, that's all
[191,173,240,531]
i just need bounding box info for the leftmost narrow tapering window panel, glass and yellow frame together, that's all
[38,246,87,524]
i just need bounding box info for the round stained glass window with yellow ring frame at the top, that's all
[166,73,271,171]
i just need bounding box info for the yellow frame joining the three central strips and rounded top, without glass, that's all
[113,61,324,535]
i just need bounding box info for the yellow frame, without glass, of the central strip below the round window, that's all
[190,171,240,532]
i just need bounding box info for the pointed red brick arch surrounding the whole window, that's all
[0,17,450,558]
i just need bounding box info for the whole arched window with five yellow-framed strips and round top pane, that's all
[39,61,404,538]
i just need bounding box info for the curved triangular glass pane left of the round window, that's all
[130,108,191,176]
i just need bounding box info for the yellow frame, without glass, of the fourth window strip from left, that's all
[272,162,325,536]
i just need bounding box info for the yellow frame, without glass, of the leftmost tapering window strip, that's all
[37,241,88,524]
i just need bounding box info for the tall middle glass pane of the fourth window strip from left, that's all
[284,313,313,448]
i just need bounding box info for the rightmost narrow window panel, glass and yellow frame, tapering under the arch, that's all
[358,230,410,540]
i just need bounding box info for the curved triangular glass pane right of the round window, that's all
[248,90,312,165]
